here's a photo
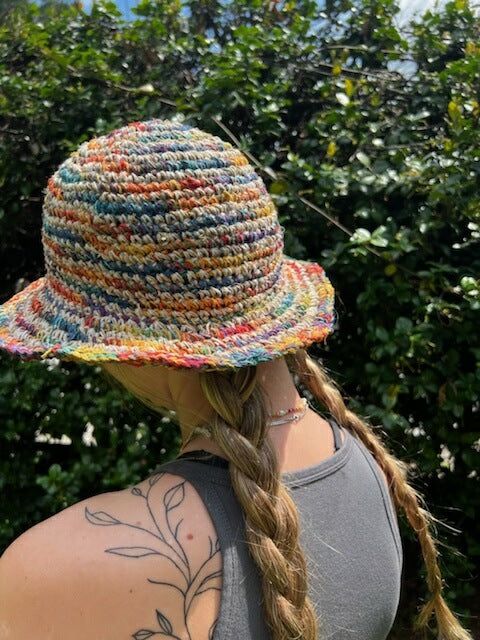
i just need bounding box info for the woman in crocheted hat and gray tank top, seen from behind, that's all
[0,119,471,640]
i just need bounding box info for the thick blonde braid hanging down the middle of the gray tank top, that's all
[200,367,318,640]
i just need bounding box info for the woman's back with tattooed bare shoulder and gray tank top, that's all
[0,418,402,640]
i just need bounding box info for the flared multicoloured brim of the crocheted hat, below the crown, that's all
[0,257,334,369]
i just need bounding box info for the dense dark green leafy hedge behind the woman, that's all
[0,0,480,638]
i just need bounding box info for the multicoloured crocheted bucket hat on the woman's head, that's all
[0,119,334,369]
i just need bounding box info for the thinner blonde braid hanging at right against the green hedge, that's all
[286,349,473,640]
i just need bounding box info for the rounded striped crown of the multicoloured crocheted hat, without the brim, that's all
[42,119,283,328]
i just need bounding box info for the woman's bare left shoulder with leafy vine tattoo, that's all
[0,473,222,640]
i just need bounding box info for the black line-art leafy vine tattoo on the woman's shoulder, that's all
[85,473,222,640]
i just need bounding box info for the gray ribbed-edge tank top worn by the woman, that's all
[156,417,403,640]
